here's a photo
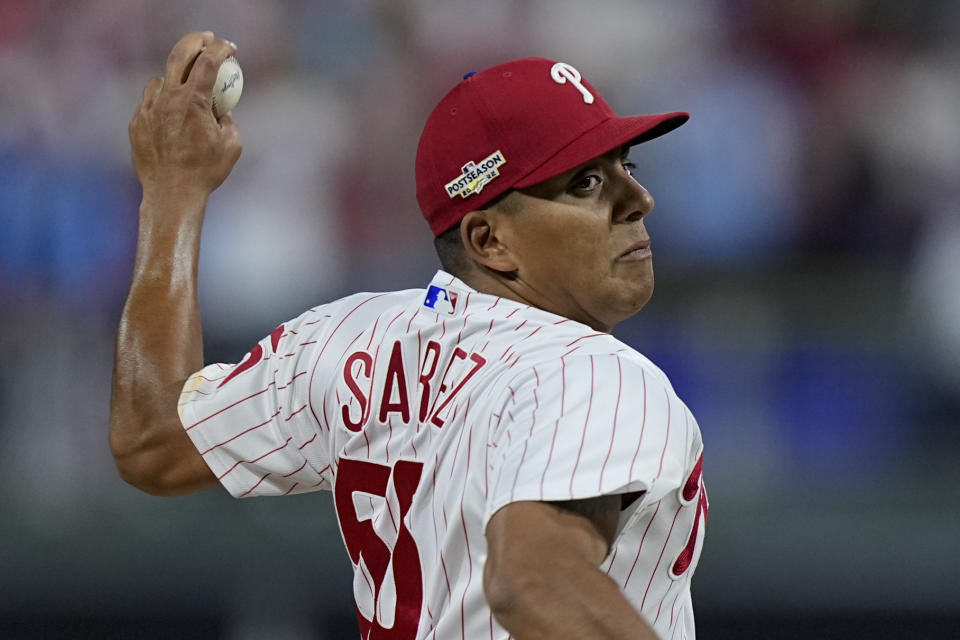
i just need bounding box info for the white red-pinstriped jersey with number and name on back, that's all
[180,271,707,640]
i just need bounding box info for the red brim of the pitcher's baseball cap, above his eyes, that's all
[513,111,690,189]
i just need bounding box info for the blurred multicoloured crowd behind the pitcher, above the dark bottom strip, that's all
[0,0,960,632]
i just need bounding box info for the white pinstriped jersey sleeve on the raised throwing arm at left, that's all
[178,307,332,498]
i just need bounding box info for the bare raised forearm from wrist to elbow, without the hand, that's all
[110,191,213,493]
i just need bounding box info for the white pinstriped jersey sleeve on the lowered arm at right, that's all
[485,354,691,519]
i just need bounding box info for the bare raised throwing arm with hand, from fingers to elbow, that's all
[110,31,242,495]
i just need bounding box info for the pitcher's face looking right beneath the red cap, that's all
[498,148,653,331]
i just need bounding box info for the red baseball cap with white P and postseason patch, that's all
[416,58,690,235]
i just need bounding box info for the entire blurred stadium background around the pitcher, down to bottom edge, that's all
[0,0,960,640]
